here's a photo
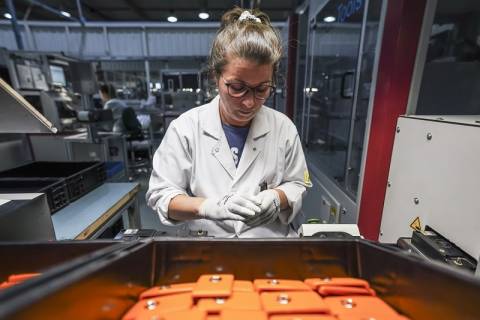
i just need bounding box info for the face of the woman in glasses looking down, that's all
[217,57,273,127]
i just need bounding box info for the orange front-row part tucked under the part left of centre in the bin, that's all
[197,291,262,313]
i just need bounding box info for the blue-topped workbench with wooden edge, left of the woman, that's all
[52,182,140,240]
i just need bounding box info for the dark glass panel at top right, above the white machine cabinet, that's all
[416,0,480,115]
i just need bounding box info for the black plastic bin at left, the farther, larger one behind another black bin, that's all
[0,161,107,202]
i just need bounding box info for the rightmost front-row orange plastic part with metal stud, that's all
[324,296,398,320]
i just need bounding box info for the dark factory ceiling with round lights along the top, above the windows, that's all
[0,0,302,22]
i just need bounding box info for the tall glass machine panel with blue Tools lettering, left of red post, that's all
[300,0,383,199]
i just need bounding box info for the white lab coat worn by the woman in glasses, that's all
[146,96,311,238]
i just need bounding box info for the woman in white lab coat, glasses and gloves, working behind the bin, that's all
[146,8,311,237]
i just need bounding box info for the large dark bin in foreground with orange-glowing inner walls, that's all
[0,239,480,320]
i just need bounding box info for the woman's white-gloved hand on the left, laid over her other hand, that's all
[198,194,260,221]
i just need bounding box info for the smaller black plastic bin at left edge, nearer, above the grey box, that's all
[0,178,70,214]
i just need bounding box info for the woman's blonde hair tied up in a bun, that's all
[209,7,282,80]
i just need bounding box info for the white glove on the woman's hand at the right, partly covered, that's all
[245,189,280,227]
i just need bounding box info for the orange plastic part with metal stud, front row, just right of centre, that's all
[260,291,329,314]
